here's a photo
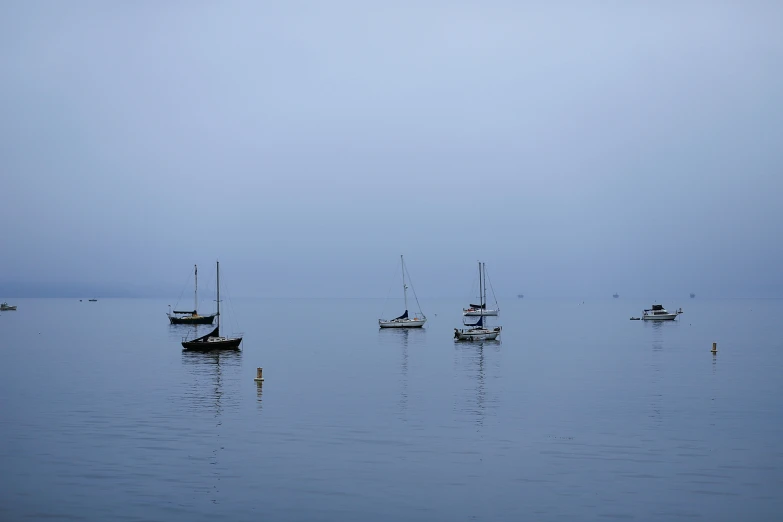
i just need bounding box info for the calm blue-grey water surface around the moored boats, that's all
[0,298,783,522]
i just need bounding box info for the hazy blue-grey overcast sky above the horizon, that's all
[0,0,783,298]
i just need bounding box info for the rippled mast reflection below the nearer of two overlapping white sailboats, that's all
[454,340,501,427]
